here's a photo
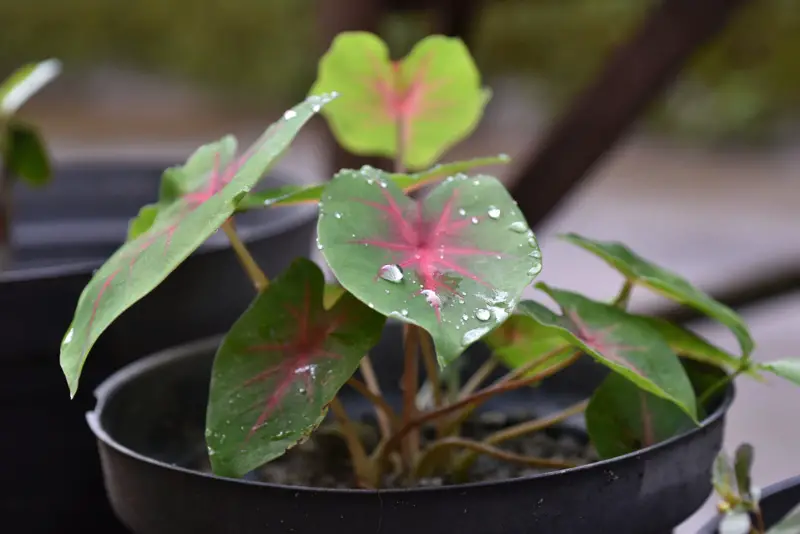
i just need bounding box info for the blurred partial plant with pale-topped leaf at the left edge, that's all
[0,59,61,272]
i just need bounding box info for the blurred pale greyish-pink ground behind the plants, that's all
[31,72,800,534]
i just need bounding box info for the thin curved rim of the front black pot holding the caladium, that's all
[86,335,736,495]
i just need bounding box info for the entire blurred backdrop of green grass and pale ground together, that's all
[0,0,800,532]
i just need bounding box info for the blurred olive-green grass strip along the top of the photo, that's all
[0,0,800,142]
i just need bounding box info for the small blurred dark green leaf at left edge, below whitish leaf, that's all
[5,121,52,187]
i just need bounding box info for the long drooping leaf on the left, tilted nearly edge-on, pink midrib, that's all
[61,95,334,396]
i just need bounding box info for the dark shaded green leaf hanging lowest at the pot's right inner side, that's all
[586,373,695,458]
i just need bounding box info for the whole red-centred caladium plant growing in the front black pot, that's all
[61,32,800,488]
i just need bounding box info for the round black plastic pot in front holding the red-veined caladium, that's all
[87,328,733,534]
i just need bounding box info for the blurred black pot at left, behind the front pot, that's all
[0,162,315,534]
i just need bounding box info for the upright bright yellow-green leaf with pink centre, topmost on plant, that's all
[311,32,490,169]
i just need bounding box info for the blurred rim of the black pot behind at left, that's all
[0,158,316,285]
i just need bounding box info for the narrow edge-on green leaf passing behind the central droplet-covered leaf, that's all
[239,154,511,211]
